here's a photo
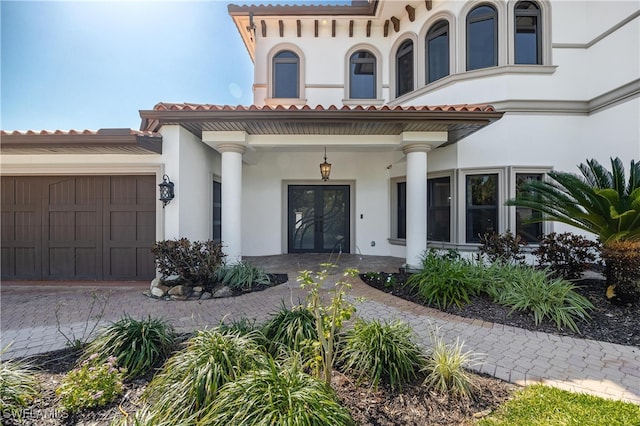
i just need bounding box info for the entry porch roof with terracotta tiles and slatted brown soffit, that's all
[140,103,503,144]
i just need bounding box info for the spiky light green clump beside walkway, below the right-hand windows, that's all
[489,267,593,332]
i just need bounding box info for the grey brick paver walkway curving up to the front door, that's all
[0,255,640,404]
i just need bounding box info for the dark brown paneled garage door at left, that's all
[1,176,156,280]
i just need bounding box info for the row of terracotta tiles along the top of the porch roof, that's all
[153,102,495,112]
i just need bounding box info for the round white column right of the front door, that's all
[402,144,431,269]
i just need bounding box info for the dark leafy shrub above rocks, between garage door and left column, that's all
[151,238,225,286]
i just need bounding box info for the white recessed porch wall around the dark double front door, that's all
[242,150,394,256]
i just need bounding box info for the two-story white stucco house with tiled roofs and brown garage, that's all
[2,0,640,279]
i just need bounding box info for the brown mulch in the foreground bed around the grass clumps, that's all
[7,346,517,426]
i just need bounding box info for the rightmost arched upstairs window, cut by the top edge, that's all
[514,1,542,65]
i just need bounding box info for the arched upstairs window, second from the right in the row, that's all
[467,5,498,71]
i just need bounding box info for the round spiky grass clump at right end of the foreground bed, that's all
[340,319,423,389]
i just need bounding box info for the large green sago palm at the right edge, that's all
[506,158,640,299]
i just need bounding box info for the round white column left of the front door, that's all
[217,143,245,264]
